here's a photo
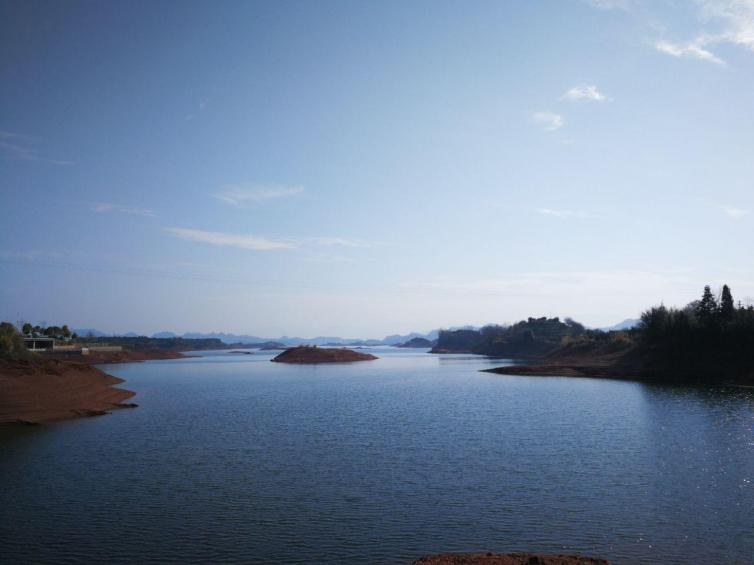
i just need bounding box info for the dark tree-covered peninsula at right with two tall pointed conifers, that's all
[482,285,754,386]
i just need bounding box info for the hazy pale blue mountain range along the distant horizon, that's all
[73,319,639,346]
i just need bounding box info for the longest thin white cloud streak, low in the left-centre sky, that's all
[165,228,375,251]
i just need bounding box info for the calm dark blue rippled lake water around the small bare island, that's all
[0,349,754,563]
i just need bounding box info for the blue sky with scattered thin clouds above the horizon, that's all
[0,0,754,337]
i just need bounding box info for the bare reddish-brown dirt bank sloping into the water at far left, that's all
[0,358,136,424]
